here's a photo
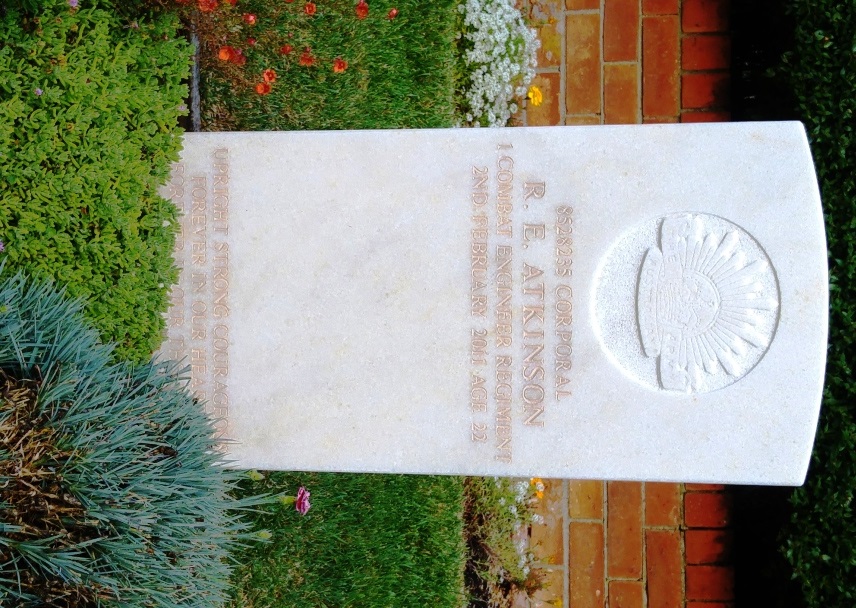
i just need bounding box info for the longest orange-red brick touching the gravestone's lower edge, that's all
[606,481,642,578]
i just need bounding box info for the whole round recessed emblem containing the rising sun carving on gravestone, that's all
[594,213,779,393]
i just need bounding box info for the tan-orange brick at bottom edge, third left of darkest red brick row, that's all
[568,522,606,608]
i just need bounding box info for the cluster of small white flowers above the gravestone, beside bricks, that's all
[458,0,540,127]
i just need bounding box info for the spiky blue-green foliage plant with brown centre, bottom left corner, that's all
[0,264,260,608]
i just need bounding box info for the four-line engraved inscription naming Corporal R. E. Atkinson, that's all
[468,144,573,463]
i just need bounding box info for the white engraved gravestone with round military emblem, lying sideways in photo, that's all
[157,123,828,484]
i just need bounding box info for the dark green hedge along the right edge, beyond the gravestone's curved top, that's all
[780,0,856,608]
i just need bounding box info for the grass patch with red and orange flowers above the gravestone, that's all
[199,0,456,131]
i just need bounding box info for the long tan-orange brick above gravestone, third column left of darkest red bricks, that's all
[565,13,601,114]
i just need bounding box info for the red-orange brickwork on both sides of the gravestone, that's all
[523,0,734,608]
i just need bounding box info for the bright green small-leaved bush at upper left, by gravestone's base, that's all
[0,0,190,362]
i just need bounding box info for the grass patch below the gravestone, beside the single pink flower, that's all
[231,473,466,608]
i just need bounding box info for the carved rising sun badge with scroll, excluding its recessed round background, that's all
[636,214,779,392]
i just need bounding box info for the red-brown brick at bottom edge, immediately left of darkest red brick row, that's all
[645,530,684,608]
